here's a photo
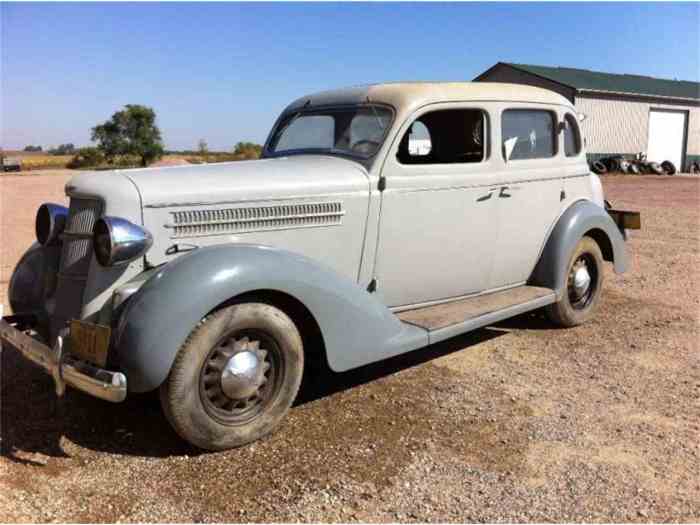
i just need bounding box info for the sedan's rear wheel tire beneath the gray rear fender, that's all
[545,237,603,327]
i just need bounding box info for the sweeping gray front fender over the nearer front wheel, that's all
[115,244,428,392]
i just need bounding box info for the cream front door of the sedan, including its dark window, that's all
[375,104,498,307]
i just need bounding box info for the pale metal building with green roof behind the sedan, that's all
[474,62,700,171]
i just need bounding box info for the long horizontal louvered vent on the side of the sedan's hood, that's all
[165,202,345,237]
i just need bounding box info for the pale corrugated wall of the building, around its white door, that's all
[574,94,700,169]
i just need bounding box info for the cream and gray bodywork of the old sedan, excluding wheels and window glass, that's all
[0,83,627,446]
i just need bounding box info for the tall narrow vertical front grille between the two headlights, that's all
[51,198,102,338]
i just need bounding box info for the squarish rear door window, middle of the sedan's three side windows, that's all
[501,109,556,161]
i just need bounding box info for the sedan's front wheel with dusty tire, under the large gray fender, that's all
[160,303,304,450]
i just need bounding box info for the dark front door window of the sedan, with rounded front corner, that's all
[396,109,487,164]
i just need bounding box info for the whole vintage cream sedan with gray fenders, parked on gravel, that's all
[0,83,639,450]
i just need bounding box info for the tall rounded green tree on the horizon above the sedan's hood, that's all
[92,104,163,166]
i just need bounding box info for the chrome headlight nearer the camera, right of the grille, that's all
[92,217,153,266]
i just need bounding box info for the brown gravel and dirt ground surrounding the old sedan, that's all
[0,177,700,522]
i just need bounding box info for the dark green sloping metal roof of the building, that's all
[505,63,700,100]
